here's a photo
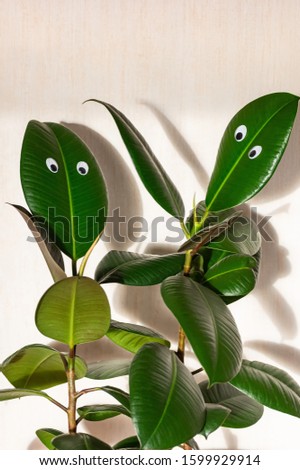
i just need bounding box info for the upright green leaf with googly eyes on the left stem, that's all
[21,121,107,260]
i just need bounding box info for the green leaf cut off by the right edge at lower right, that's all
[231,360,300,418]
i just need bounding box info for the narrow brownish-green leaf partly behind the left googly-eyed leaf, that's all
[10,204,67,282]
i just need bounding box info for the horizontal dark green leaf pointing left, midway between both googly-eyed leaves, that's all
[95,250,184,286]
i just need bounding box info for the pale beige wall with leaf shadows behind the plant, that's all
[0,0,300,449]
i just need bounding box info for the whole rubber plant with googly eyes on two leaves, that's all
[0,93,300,450]
